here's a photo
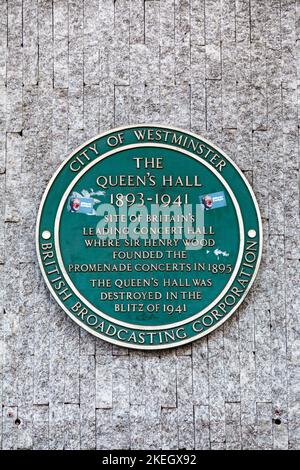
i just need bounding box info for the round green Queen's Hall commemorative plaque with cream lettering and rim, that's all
[37,125,262,350]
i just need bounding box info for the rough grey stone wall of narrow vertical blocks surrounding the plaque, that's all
[0,0,300,449]
